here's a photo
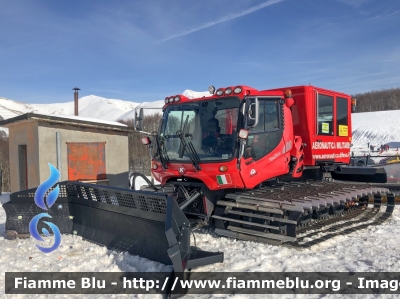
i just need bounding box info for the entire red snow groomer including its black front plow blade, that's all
[3,86,394,282]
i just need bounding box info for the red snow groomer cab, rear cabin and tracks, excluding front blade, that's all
[134,86,394,246]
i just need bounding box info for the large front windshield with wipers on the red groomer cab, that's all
[155,97,240,162]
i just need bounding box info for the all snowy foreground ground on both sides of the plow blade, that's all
[0,195,400,298]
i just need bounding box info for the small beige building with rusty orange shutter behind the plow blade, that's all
[0,113,132,192]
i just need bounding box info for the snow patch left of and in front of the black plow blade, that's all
[0,194,171,298]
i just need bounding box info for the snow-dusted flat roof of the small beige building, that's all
[0,113,134,132]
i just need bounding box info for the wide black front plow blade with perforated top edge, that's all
[3,181,223,272]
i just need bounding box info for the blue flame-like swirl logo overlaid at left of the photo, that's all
[29,163,61,253]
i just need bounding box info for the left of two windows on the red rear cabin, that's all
[317,94,333,135]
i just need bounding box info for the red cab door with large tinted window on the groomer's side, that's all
[240,96,288,189]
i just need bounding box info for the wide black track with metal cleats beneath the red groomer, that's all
[215,181,394,248]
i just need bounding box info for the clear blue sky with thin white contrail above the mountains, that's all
[0,0,400,103]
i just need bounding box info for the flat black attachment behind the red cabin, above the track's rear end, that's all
[330,166,387,183]
